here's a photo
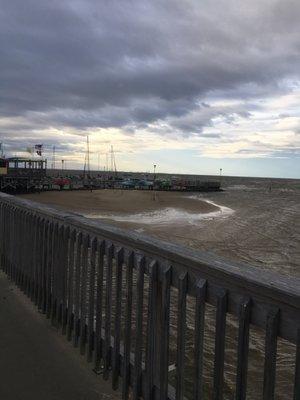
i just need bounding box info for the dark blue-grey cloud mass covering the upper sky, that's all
[0,0,300,135]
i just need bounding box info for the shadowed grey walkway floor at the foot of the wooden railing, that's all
[0,272,120,400]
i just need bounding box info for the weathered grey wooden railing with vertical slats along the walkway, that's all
[0,193,300,400]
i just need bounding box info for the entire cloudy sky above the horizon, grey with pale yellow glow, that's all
[0,0,300,178]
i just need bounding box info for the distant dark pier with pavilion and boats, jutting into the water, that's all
[0,157,221,194]
